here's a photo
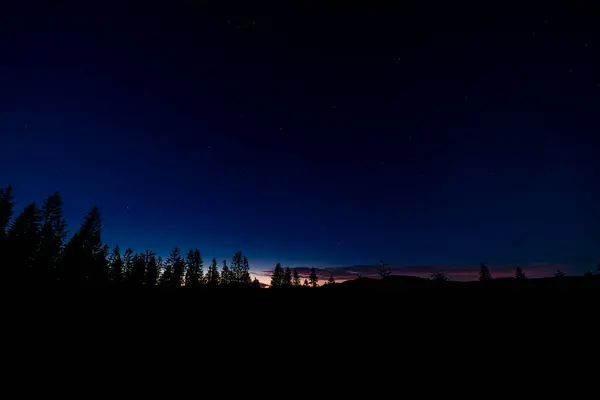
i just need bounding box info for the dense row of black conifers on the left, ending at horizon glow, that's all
[0,186,260,288]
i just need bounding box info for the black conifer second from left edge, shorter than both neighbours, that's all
[5,203,44,284]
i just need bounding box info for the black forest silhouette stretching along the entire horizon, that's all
[0,186,600,290]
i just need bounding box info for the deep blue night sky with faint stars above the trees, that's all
[0,1,600,278]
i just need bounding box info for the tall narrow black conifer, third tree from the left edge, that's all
[36,192,67,281]
